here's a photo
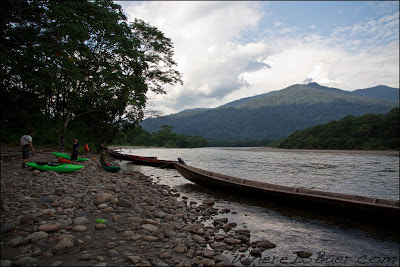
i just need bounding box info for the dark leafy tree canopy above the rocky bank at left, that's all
[0,0,182,147]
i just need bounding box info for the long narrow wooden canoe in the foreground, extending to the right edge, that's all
[174,162,400,220]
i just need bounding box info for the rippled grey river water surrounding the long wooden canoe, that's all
[115,147,400,266]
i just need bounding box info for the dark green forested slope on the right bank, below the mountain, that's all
[277,108,400,150]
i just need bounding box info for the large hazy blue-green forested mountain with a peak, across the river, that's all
[141,83,398,140]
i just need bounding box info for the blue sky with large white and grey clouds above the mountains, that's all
[115,1,399,116]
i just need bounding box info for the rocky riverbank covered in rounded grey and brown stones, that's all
[1,150,282,266]
